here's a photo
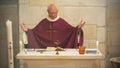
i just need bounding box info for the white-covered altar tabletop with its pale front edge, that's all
[16,49,102,59]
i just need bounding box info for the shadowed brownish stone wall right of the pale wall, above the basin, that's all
[106,0,120,68]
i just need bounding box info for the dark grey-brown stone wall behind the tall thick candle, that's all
[0,0,19,68]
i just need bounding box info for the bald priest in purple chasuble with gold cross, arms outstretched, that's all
[21,4,85,48]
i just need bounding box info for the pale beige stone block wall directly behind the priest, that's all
[19,0,106,68]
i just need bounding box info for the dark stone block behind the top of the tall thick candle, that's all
[0,14,18,35]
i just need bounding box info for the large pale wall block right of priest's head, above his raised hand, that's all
[62,7,105,26]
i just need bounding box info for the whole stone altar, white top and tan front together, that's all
[16,49,103,68]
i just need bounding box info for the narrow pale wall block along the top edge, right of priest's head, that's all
[57,0,106,6]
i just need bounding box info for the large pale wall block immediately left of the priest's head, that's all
[19,6,47,24]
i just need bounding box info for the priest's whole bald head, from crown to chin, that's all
[47,4,58,19]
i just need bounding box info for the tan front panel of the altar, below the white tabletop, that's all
[24,59,100,68]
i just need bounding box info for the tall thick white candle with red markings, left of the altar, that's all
[6,20,14,68]
